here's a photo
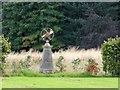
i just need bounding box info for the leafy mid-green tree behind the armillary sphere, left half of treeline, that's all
[3,2,63,51]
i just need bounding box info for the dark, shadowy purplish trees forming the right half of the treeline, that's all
[62,2,120,49]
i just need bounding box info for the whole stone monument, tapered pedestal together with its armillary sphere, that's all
[40,28,54,73]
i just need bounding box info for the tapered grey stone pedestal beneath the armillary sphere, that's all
[40,41,54,73]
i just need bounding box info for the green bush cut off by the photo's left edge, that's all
[0,35,11,75]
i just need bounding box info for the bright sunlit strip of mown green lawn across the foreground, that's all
[2,77,118,88]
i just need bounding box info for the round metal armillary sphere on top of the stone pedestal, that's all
[41,28,54,41]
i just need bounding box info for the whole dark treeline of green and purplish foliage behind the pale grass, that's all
[2,2,120,51]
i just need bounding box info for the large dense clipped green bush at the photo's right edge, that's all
[102,37,120,76]
